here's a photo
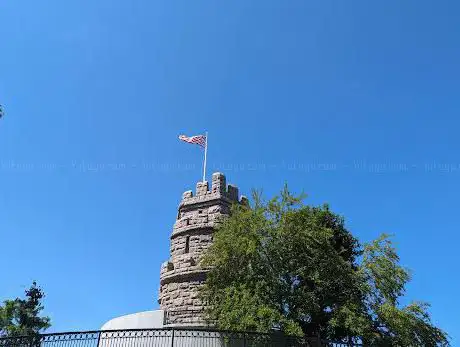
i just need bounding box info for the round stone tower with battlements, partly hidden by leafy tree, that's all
[158,173,247,326]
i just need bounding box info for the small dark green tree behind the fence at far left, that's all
[0,281,51,336]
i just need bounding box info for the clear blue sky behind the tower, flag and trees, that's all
[0,0,460,345]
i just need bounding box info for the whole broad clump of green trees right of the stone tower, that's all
[201,187,448,346]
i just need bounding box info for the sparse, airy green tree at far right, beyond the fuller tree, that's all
[332,234,449,346]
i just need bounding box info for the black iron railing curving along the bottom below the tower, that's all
[0,328,360,347]
